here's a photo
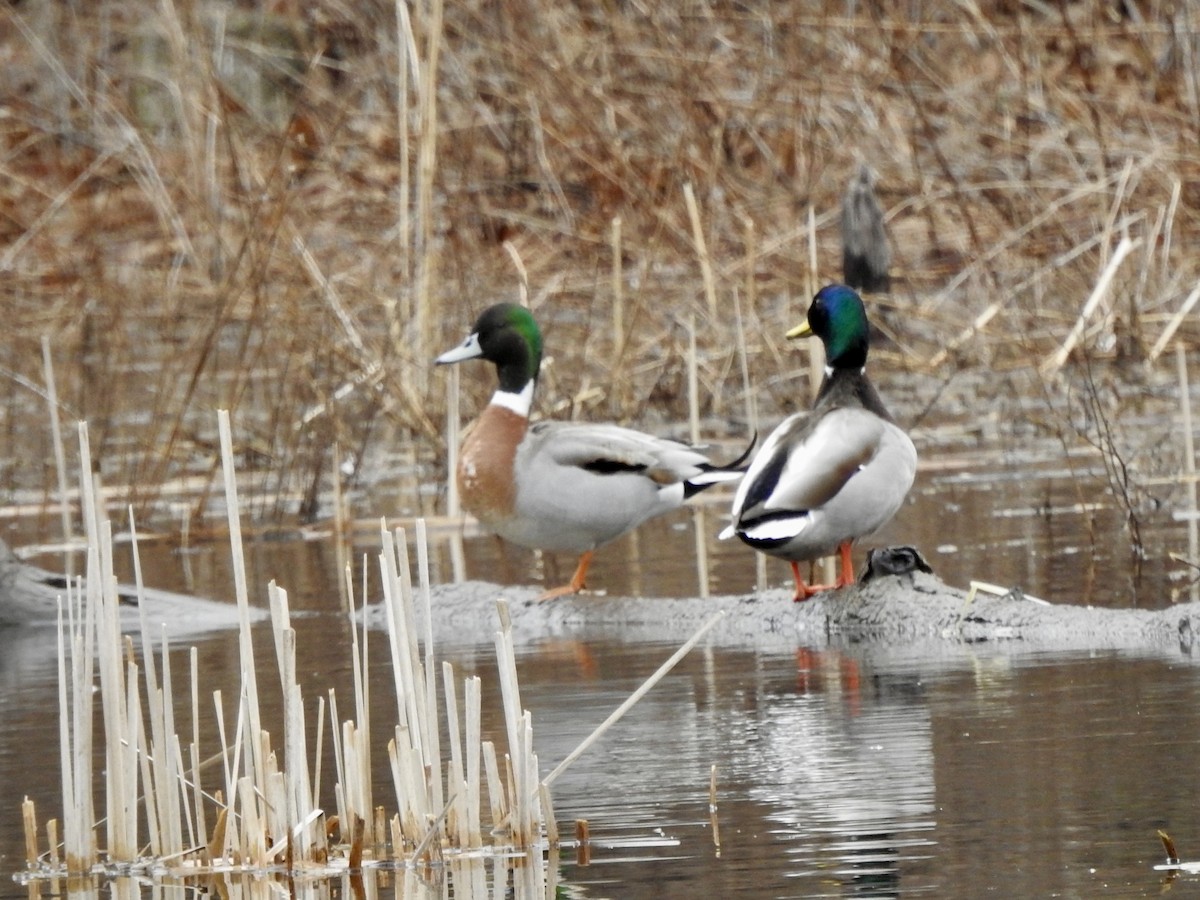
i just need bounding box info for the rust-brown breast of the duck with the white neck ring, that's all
[458,406,529,524]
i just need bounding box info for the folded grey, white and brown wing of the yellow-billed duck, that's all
[734,407,887,521]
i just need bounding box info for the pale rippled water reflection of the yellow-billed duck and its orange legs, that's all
[751,649,935,898]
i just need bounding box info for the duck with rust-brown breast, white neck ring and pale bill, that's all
[436,304,752,600]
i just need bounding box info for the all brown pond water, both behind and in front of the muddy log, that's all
[0,436,1200,899]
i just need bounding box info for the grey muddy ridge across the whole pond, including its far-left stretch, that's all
[7,528,1200,655]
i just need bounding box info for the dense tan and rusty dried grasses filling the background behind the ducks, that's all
[0,0,1200,535]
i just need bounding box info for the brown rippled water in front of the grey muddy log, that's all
[7,617,1200,900]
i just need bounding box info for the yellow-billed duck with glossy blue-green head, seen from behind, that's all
[720,284,917,601]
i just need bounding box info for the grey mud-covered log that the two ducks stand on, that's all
[403,572,1200,654]
